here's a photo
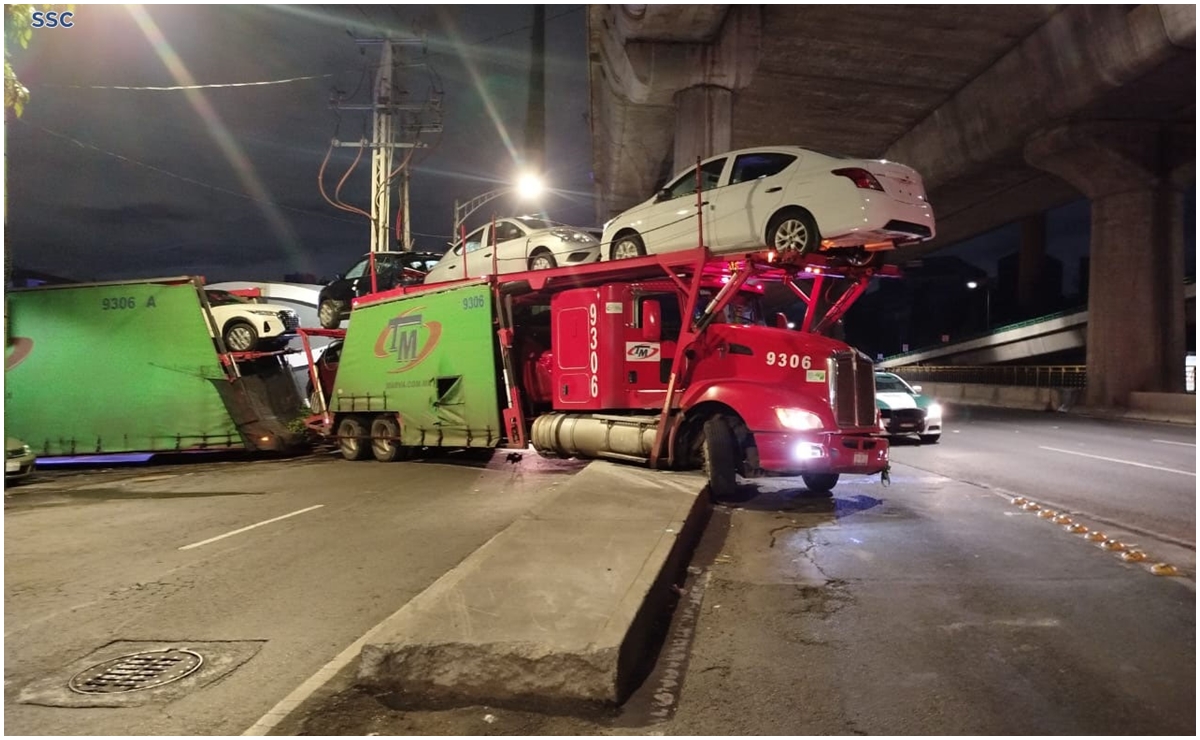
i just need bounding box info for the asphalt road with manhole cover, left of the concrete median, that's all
[4,450,578,736]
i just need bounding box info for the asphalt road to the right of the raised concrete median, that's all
[284,410,1196,735]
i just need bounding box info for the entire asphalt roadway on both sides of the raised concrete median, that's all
[5,410,1196,735]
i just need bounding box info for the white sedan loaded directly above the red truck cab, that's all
[600,146,935,264]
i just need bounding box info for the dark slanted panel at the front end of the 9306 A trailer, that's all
[212,357,307,452]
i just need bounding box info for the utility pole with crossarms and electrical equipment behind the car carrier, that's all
[334,38,442,252]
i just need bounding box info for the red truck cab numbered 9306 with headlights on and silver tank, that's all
[516,267,888,495]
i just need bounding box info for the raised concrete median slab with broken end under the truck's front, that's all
[358,462,709,708]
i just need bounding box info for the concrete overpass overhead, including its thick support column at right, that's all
[588,5,1195,405]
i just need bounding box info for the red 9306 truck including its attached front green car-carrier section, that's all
[313,249,895,498]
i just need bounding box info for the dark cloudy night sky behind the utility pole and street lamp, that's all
[5,5,595,282]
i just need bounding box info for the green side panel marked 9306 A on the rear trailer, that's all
[5,281,245,456]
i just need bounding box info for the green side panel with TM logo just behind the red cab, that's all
[330,284,500,447]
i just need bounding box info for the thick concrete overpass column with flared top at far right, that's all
[1025,121,1195,407]
